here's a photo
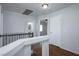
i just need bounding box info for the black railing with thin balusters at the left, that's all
[0,33,33,46]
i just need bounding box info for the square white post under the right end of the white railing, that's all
[42,40,49,56]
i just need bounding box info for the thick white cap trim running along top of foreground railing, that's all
[0,36,49,56]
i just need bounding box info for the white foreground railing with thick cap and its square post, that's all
[0,36,49,56]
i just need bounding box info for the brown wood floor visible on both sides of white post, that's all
[32,44,79,56]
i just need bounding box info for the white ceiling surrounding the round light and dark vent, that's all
[2,3,73,16]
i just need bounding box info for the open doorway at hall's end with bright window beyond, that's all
[40,19,48,36]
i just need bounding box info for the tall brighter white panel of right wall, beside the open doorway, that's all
[49,15,62,46]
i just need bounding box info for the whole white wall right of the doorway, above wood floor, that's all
[38,4,79,54]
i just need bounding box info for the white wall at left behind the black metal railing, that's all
[3,11,35,33]
